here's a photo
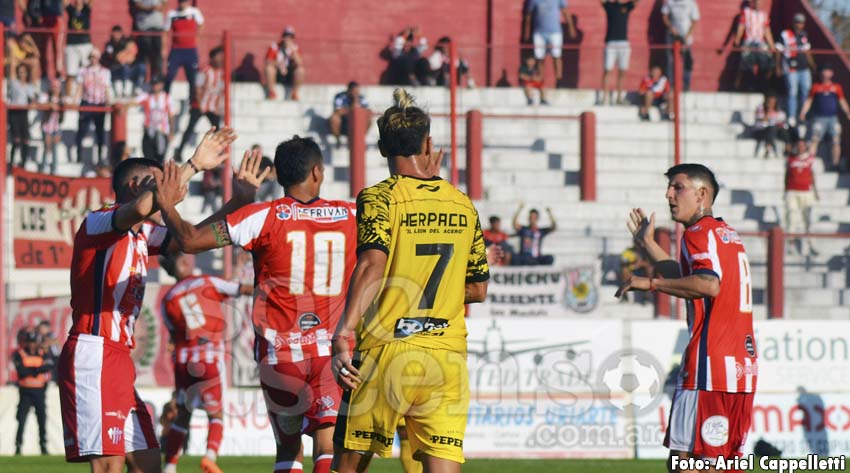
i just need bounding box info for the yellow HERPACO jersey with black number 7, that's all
[358,175,489,352]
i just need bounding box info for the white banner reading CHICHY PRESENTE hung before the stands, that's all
[469,266,599,317]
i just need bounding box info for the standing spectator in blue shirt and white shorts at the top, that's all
[523,0,576,87]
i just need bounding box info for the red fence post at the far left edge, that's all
[0,23,7,386]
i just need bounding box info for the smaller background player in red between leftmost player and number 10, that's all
[159,253,254,473]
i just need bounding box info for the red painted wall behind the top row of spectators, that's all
[69,0,827,90]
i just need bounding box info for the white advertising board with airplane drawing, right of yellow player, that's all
[464,317,633,458]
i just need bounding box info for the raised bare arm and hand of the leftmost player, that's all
[112,128,236,231]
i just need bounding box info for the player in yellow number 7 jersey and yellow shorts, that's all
[333,89,490,473]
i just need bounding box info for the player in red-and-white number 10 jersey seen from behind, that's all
[152,136,356,473]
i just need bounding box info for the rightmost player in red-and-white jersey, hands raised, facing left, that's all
[617,164,758,471]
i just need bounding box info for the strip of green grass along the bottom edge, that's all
[0,456,796,473]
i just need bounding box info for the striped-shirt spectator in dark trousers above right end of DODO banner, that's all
[73,48,112,172]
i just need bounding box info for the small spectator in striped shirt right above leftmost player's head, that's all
[135,77,176,163]
